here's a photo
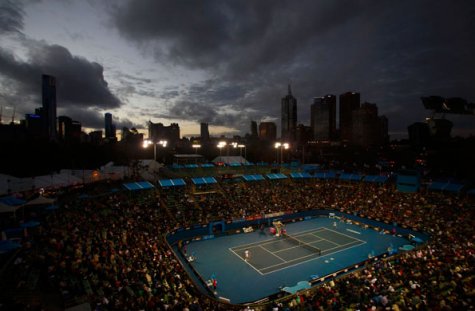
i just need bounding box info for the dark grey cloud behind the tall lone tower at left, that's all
[0,40,121,109]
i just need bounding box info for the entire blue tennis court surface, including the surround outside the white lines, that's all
[187,218,409,303]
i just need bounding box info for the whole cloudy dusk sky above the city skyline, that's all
[0,0,475,137]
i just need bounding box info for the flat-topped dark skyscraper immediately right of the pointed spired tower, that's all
[310,95,336,140]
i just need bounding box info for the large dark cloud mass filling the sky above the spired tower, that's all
[113,0,475,134]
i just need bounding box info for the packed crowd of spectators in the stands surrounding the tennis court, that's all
[0,180,475,310]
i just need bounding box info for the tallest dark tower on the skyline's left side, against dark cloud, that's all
[42,75,57,140]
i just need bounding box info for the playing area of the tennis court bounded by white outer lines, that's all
[230,228,366,275]
